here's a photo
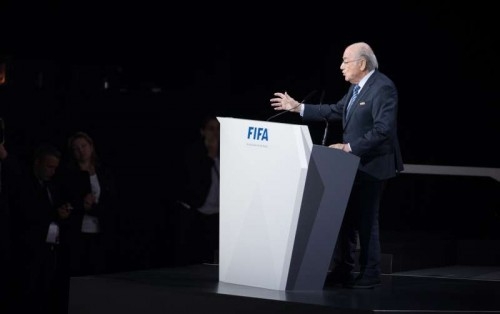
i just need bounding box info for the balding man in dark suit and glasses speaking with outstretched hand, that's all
[271,42,403,288]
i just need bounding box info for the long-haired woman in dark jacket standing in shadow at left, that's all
[61,132,118,276]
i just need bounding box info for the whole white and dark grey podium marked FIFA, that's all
[218,117,359,290]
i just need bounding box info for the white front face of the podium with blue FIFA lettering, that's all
[219,118,312,290]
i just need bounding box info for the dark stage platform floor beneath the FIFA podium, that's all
[69,265,500,314]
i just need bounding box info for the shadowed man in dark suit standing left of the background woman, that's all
[6,145,72,314]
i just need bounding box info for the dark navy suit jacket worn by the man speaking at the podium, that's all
[303,70,403,180]
